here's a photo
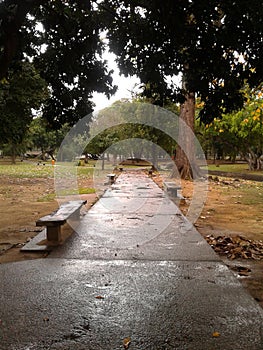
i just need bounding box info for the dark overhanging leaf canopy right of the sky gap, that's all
[100,0,263,122]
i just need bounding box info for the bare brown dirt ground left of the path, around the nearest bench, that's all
[0,176,97,263]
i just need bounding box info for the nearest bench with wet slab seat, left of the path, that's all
[36,200,87,244]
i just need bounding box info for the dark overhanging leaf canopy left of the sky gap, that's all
[0,0,115,127]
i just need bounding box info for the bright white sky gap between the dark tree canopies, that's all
[92,53,140,111]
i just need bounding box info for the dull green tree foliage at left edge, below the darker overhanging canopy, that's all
[0,61,48,161]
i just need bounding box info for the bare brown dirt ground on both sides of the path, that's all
[0,170,263,307]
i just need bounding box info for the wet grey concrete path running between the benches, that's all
[0,172,263,350]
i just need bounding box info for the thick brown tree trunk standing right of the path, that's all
[175,92,200,179]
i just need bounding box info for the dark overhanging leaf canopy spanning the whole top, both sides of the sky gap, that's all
[0,0,263,124]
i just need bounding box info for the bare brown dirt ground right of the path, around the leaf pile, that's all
[180,176,263,308]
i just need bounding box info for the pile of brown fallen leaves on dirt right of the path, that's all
[205,235,263,260]
